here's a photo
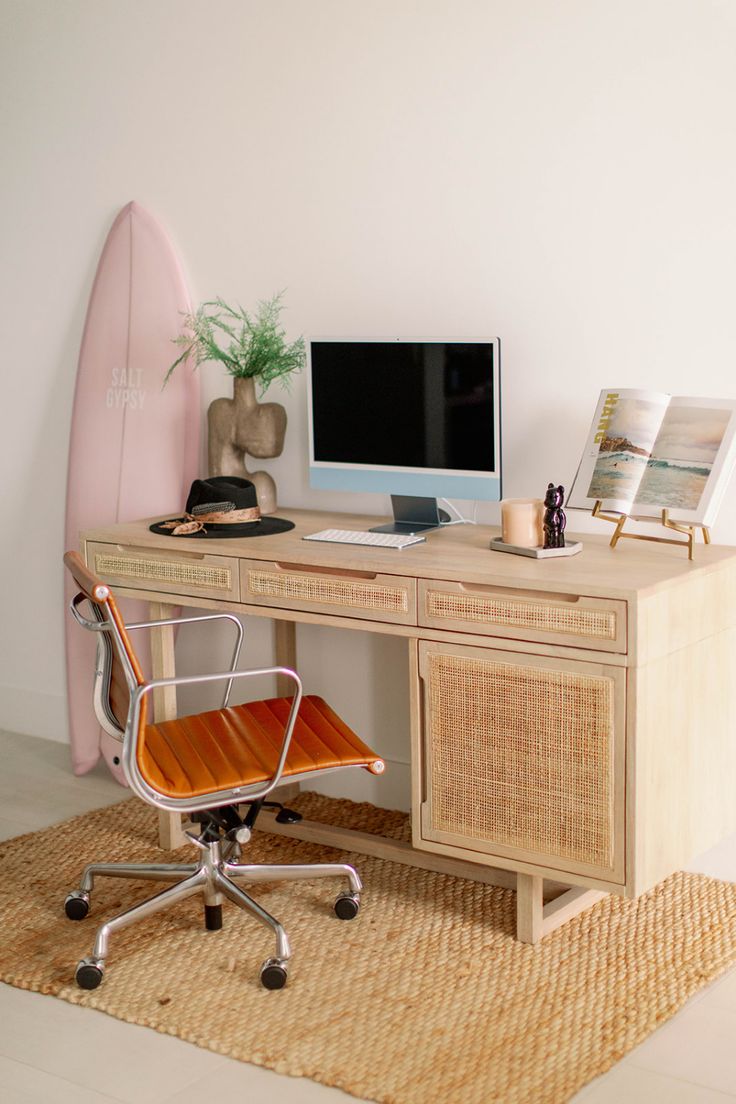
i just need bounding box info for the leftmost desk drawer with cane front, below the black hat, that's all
[87,543,241,602]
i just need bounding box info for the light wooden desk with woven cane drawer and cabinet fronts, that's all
[82,508,736,943]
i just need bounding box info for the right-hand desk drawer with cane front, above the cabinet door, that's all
[419,580,627,652]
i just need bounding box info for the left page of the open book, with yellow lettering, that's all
[567,389,670,513]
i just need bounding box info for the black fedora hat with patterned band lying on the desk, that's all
[149,476,294,538]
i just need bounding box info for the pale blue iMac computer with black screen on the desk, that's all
[307,338,501,533]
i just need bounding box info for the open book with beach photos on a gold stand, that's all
[567,390,736,526]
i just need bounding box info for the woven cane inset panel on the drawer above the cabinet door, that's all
[427,591,616,640]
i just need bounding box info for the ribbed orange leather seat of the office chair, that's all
[138,694,384,797]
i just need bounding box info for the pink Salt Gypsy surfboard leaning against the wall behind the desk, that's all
[64,203,201,783]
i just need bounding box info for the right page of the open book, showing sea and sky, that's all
[633,397,736,526]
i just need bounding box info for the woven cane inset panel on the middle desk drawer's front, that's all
[248,571,409,613]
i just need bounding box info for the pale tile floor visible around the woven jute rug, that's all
[0,733,736,1104]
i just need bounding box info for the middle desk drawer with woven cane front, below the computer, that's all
[241,560,417,625]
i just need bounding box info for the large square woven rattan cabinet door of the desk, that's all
[417,640,626,884]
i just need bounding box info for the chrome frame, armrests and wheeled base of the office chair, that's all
[65,587,362,989]
